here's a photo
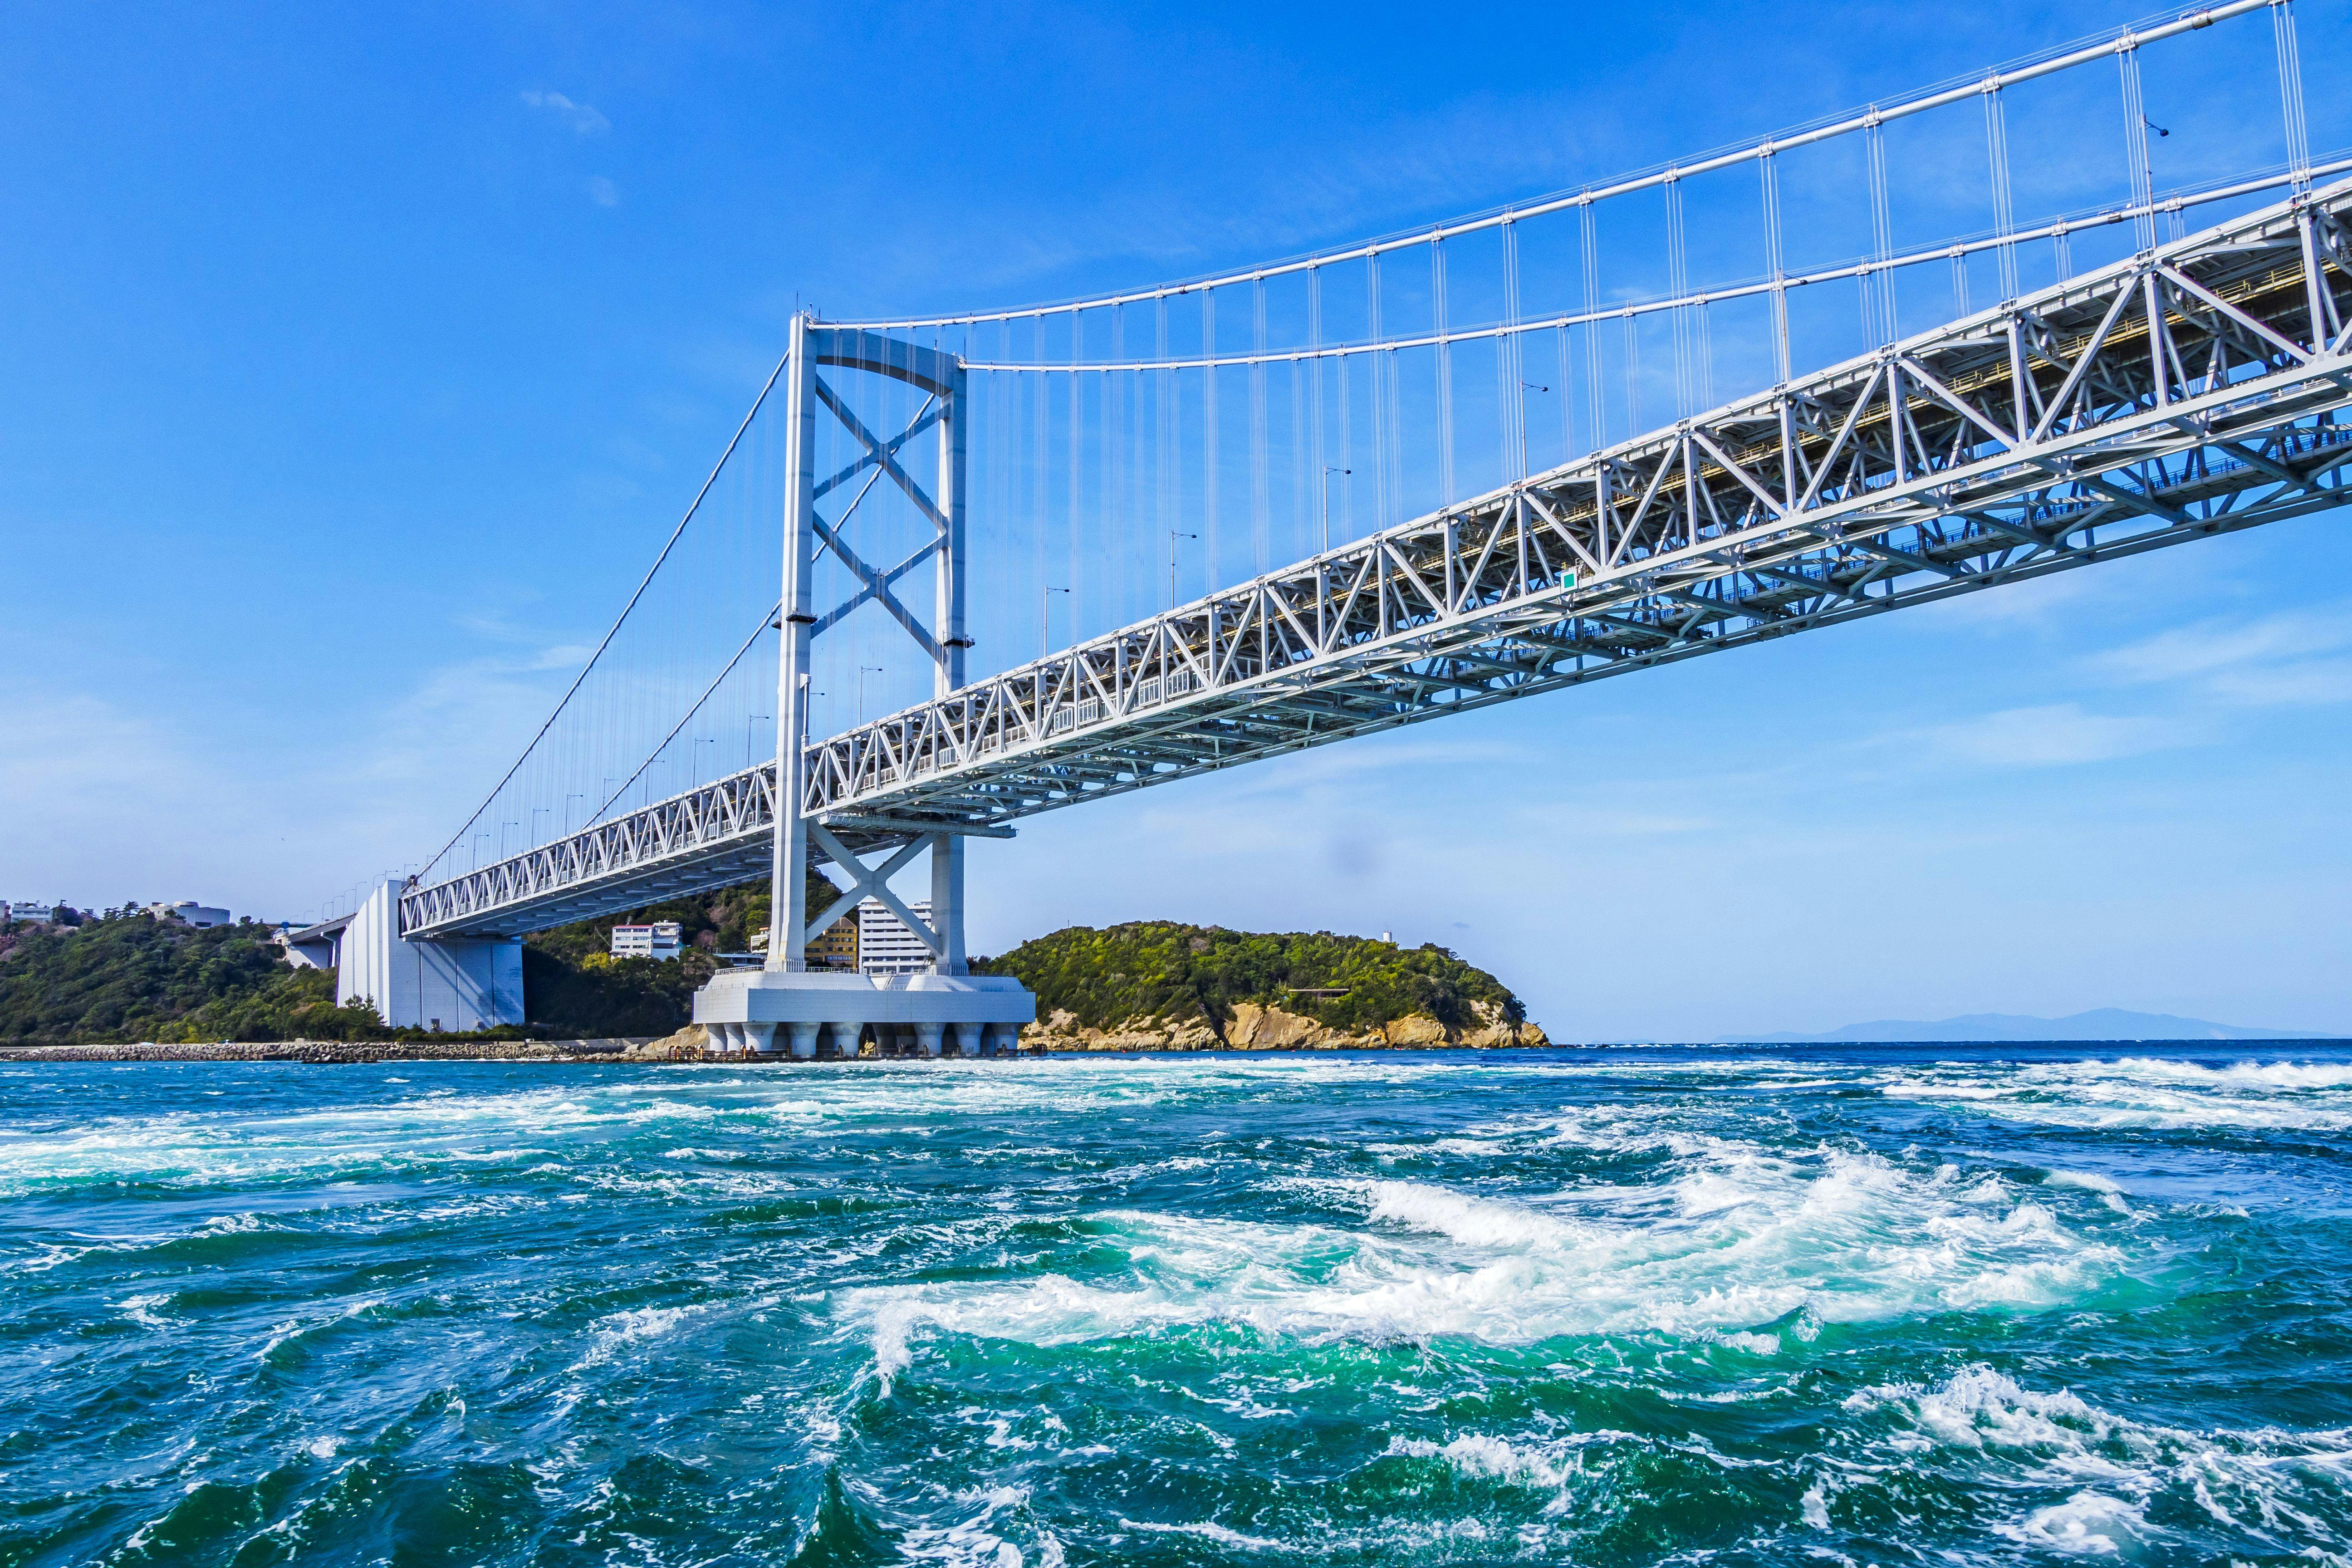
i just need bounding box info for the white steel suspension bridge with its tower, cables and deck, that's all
[296,0,2352,1055]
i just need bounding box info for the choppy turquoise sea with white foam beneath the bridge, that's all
[0,1046,2352,1568]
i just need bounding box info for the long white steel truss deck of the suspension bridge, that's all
[402,181,2352,936]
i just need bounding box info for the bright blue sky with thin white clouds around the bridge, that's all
[0,0,2352,1039]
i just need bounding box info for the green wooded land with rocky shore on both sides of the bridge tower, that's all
[0,877,1548,1051]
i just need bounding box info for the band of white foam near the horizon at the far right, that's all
[1877,1055,2352,1131]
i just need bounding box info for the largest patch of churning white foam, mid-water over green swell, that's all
[835,1138,2133,1380]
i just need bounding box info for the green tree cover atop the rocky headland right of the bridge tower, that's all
[974,921,1526,1034]
